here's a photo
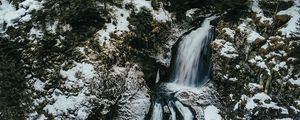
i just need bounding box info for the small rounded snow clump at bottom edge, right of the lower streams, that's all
[204,105,222,120]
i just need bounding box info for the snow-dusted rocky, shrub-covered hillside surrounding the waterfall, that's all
[0,0,300,120]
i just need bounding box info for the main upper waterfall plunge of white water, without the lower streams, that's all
[171,17,215,87]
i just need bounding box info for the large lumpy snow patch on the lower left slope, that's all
[34,62,96,119]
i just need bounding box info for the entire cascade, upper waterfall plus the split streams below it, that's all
[150,16,216,120]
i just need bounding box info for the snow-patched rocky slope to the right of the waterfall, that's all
[212,1,299,119]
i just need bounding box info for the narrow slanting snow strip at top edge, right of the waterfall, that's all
[251,0,273,24]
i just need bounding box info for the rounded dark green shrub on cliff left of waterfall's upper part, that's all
[125,8,171,52]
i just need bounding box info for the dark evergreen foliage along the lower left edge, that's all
[0,38,31,120]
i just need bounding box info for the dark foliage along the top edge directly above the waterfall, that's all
[164,0,249,21]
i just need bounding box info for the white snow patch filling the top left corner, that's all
[0,0,43,32]
